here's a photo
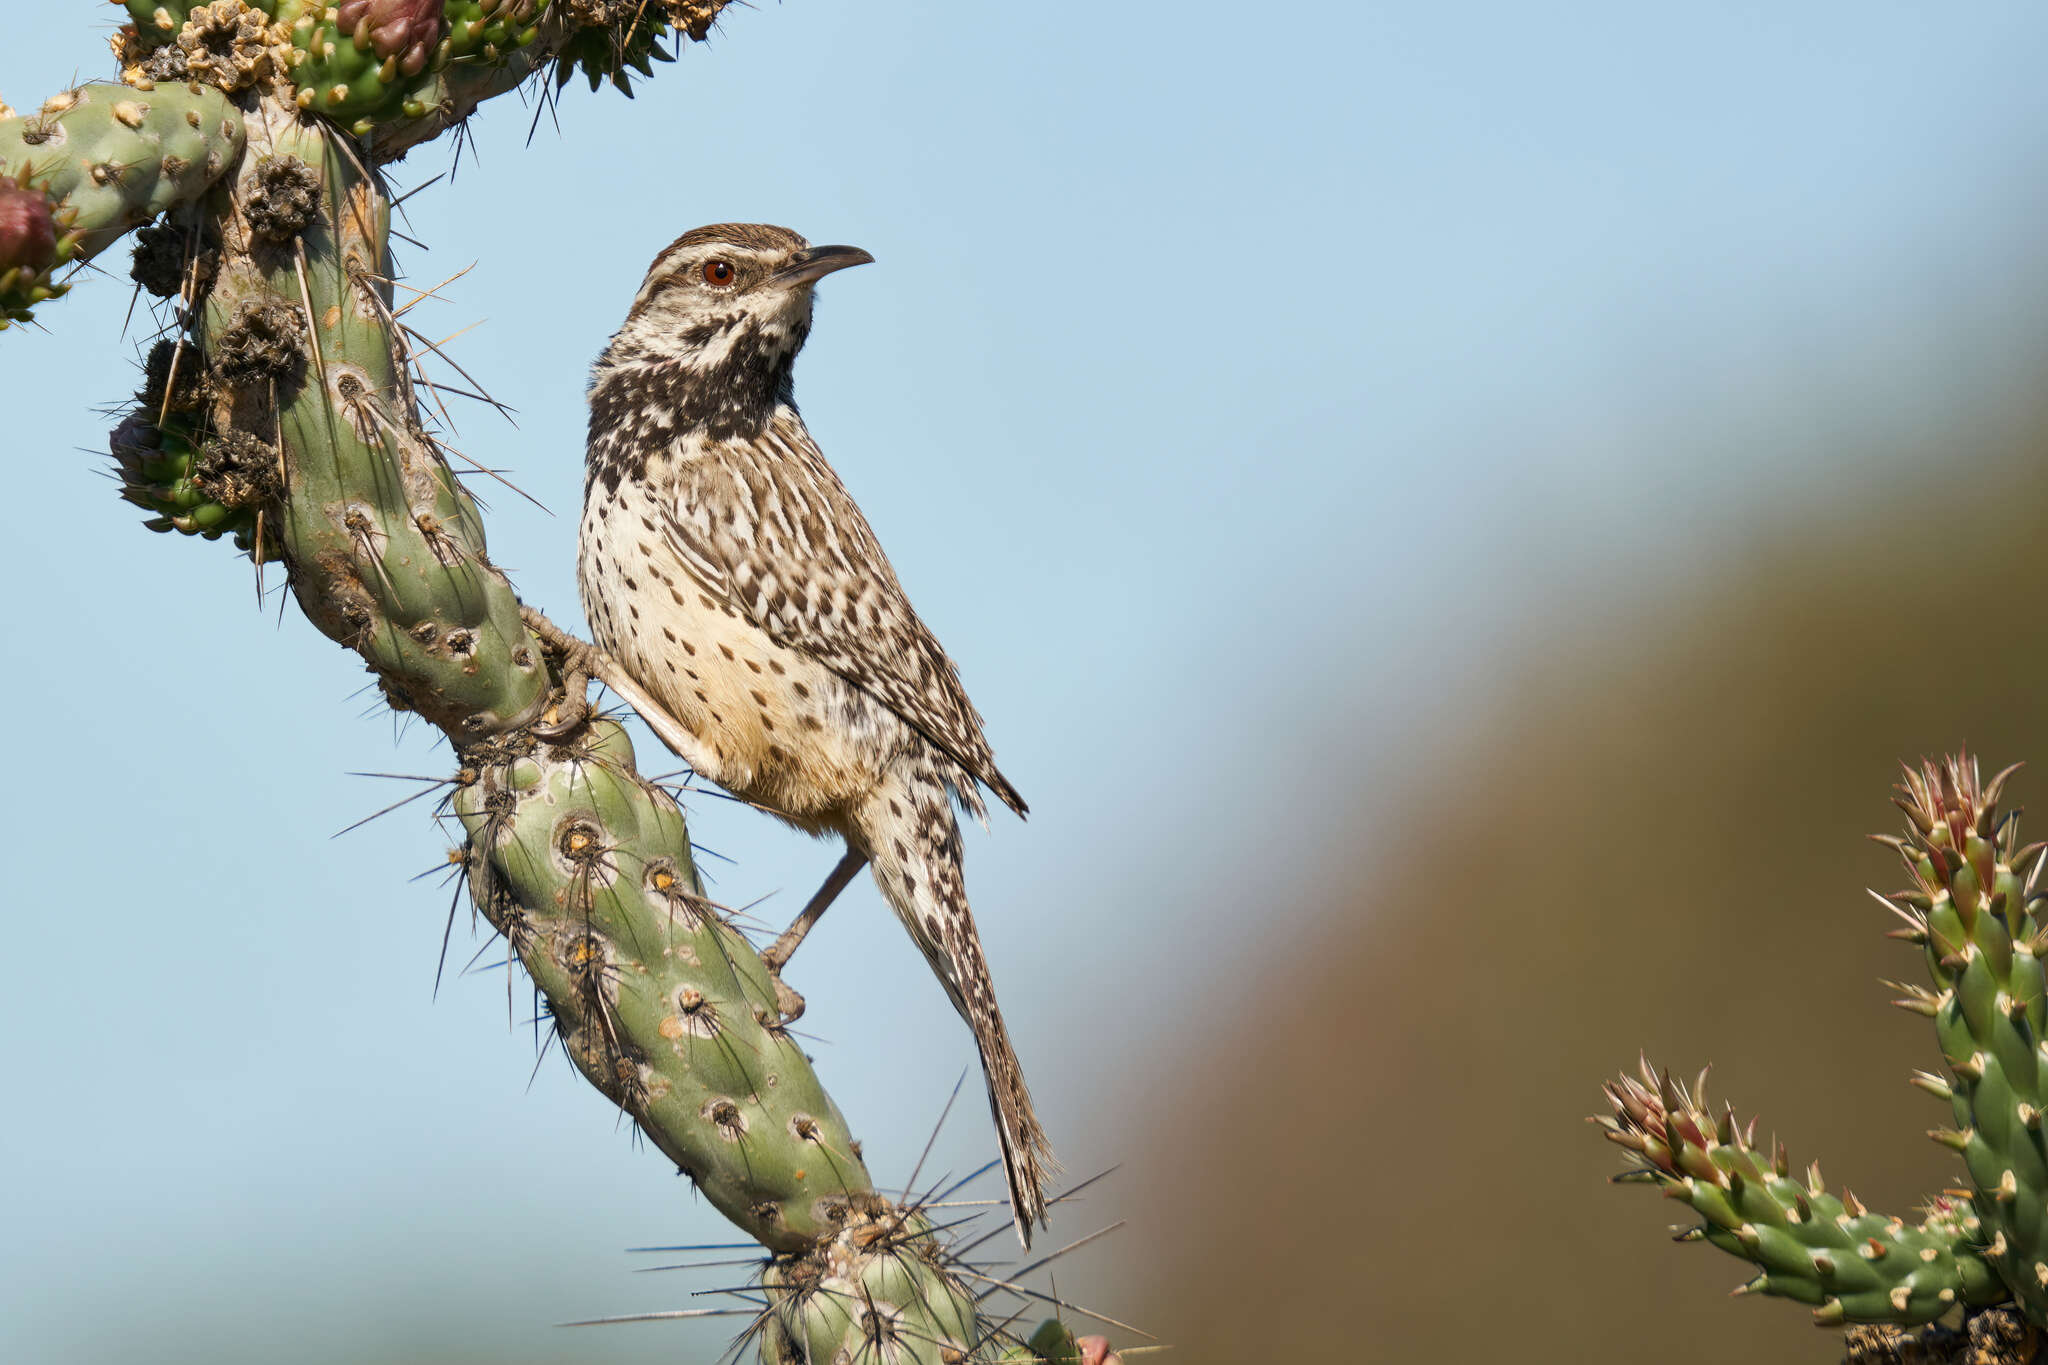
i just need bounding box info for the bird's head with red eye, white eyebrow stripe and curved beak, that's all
[606,223,874,375]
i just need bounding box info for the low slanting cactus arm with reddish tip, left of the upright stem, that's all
[1593,1062,2007,1326]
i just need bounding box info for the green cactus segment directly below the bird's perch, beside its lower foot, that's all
[455,720,887,1252]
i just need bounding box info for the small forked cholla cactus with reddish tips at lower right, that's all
[1595,755,2048,1340]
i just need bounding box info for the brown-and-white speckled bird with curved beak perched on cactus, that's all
[578,223,1057,1248]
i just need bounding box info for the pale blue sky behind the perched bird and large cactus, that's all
[12,0,2048,1361]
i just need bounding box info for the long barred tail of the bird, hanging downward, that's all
[868,780,1059,1250]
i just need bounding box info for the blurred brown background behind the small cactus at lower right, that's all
[1098,382,2048,1363]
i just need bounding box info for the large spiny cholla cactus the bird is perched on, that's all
[0,0,1114,1365]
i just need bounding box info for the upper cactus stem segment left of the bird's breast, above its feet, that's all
[181,108,549,739]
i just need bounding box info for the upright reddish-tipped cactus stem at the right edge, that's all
[1886,755,2048,1322]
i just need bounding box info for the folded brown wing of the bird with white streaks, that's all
[662,413,1026,814]
